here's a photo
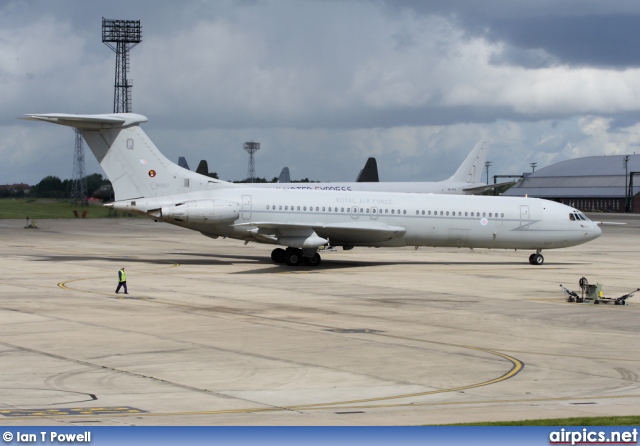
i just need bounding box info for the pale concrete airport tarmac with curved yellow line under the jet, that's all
[0,214,640,426]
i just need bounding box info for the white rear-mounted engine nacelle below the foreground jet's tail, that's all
[161,200,240,223]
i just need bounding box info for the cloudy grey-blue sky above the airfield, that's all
[0,0,640,184]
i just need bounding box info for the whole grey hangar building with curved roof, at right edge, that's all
[504,155,640,212]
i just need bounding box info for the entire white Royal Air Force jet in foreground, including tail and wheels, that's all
[25,113,600,266]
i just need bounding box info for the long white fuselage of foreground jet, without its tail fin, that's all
[114,188,600,249]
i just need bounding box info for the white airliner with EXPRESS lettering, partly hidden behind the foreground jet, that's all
[256,142,496,195]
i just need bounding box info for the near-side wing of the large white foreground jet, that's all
[237,221,406,245]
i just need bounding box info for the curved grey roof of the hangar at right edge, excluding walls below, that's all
[504,155,640,198]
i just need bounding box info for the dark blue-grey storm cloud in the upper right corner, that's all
[387,0,640,68]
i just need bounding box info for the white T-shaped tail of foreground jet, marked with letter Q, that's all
[23,113,224,201]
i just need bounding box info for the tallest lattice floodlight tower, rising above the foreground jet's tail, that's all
[102,17,142,113]
